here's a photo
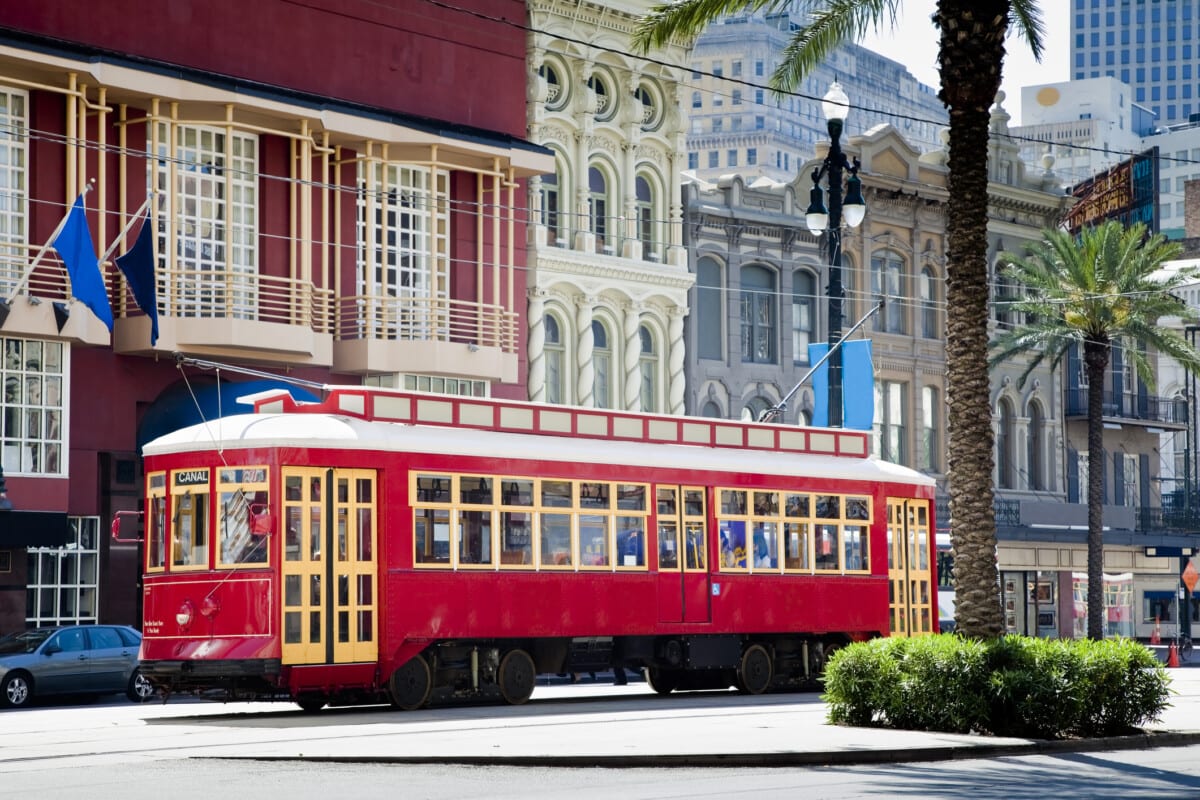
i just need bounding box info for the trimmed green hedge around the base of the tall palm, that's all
[822,634,1171,739]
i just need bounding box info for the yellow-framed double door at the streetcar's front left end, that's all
[280,468,378,664]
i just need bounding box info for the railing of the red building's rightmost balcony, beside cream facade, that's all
[335,295,517,353]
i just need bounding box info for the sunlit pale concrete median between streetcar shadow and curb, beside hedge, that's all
[206,668,1200,768]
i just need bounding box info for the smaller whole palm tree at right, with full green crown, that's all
[990,221,1200,639]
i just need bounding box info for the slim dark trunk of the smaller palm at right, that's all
[1084,341,1109,639]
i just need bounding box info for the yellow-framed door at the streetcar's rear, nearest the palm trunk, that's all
[888,498,934,636]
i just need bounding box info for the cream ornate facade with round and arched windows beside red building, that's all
[527,0,692,414]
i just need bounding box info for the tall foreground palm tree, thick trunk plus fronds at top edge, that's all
[634,0,1042,638]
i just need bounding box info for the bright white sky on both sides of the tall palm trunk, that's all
[851,0,1072,125]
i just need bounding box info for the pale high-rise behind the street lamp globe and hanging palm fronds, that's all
[684,12,949,182]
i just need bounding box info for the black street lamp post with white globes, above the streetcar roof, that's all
[804,80,866,428]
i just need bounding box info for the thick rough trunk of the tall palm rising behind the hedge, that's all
[936,0,1009,638]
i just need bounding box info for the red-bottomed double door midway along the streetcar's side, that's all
[655,486,712,622]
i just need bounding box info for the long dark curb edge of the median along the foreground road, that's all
[208,730,1200,769]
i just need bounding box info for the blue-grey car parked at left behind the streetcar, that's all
[0,625,155,708]
